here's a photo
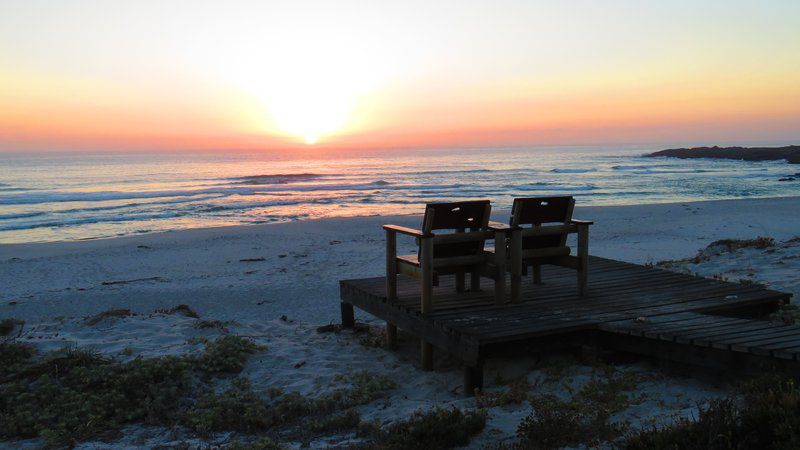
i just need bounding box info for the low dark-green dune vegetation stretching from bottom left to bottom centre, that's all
[0,328,486,449]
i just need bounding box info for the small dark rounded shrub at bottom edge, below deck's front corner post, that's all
[377,407,486,450]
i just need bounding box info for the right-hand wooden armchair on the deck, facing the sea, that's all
[509,196,593,302]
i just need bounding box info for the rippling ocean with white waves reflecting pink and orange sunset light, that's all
[0,146,800,243]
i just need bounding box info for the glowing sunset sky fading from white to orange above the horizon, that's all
[0,0,800,151]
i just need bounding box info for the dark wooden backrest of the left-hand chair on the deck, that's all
[422,200,492,259]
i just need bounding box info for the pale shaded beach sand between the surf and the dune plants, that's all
[0,198,800,447]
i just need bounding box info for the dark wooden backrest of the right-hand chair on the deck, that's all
[511,196,575,250]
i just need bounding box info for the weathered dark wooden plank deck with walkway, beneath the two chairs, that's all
[340,257,800,392]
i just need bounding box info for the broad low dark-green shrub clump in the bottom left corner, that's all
[0,350,190,444]
